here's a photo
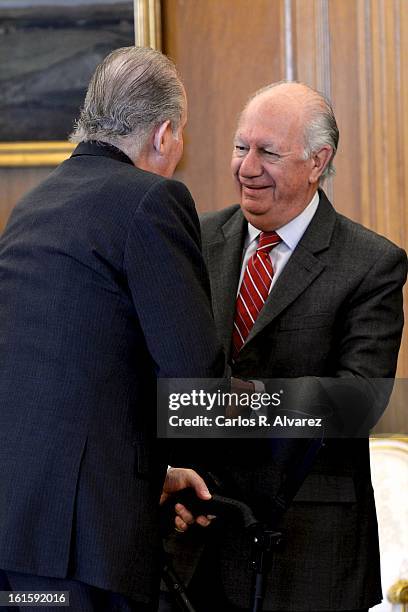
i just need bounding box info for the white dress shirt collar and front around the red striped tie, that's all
[237,191,319,295]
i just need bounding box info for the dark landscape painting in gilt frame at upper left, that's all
[0,0,139,165]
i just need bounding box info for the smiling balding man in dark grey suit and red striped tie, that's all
[164,83,407,612]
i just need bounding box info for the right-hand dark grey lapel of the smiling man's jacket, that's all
[244,191,336,348]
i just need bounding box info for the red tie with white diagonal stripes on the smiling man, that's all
[232,232,281,359]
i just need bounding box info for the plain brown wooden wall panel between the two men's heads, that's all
[162,0,285,211]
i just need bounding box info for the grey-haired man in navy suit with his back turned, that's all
[0,47,224,612]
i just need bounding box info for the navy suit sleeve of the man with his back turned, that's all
[124,180,225,378]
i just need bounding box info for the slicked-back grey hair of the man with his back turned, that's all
[70,47,186,157]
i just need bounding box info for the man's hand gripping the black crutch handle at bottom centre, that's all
[160,468,214,532]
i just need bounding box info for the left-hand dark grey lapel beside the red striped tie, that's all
[207,209,247,359]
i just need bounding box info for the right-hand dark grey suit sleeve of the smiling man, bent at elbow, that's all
[266,245,407,437]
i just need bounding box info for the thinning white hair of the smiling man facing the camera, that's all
[244,81,339,181]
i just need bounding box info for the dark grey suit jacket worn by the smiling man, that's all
[167,191,407,612]
